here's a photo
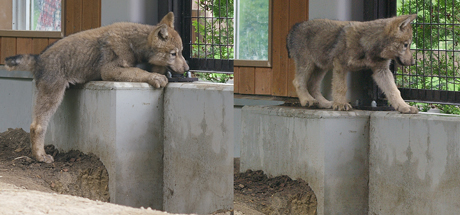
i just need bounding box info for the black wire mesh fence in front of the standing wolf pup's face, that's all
[395,0,460,104]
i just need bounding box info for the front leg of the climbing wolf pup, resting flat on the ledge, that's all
[101,64,168,88]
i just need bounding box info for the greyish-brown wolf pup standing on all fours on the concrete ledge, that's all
[286,14,418,113]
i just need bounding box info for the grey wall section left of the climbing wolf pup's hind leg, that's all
[0,69,35,132]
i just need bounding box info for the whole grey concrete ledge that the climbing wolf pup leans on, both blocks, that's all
[42,81,233,214]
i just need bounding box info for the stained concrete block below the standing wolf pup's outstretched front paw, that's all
[369,112,460,214]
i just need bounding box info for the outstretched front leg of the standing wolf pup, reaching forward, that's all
[372,69,418,114]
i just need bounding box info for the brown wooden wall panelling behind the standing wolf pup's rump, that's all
[234,0,308,97]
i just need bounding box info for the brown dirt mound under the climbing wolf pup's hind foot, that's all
[0,128,109,202]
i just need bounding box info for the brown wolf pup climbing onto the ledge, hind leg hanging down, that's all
[5,13,189,163]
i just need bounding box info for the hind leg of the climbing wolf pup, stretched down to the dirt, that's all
[30,82,67,163]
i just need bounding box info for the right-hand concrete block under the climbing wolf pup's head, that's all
[163,84,233,214]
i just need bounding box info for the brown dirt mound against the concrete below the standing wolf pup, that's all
[234,162,317,214]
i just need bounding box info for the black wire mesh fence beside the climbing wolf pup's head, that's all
[183,0,234,72]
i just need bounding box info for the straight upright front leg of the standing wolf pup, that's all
[332,61,352,111]
